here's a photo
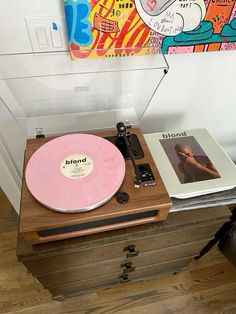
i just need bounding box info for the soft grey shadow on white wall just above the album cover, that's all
[140,113,184,133]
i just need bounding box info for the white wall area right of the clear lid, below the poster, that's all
[142,51,236,160]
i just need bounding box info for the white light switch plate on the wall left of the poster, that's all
[25,15,68,52]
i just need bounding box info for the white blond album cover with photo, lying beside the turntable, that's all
[145,129,236,198]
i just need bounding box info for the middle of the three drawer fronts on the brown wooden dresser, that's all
[37,240,207,287]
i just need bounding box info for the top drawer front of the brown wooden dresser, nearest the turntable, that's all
[22,223,222,275]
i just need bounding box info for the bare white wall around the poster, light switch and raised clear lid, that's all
[0,0,236,211]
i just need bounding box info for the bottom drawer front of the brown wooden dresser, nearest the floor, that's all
[49,257,192,296]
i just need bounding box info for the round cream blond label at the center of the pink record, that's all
[60,154,93,179]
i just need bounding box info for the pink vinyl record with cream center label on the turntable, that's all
[25,134,125,213]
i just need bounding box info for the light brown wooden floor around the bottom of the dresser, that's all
[0,188,236,314]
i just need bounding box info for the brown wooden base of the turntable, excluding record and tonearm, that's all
[19,128,171,245]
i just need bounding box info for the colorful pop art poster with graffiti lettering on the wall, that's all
[64,0,236,59]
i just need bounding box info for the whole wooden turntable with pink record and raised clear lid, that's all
[0,52,171,244]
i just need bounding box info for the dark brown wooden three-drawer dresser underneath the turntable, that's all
[17,206,230,299]
